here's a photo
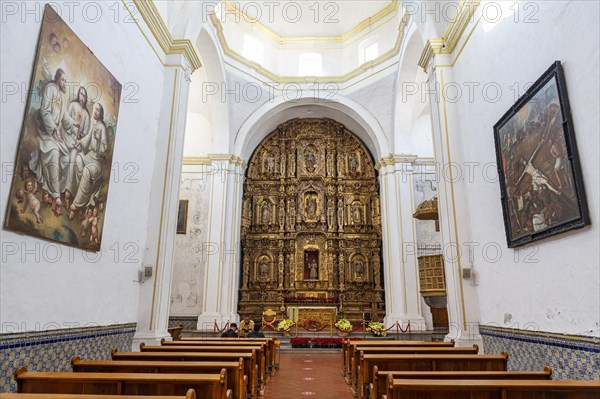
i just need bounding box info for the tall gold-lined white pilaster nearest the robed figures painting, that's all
[133,55,191,350]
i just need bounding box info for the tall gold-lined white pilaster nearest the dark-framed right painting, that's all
[427,54,483,352]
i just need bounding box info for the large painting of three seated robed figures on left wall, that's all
[3,5,121,251]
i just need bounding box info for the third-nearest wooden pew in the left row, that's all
[71,356,248,399]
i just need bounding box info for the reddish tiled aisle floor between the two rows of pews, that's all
[264,353,352,399]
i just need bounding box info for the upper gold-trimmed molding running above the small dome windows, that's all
[223,0,400,45]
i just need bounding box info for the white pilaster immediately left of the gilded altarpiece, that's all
[197,154,246,330]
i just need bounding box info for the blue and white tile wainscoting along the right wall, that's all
[479,325,600,380]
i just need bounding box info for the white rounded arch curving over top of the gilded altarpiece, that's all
[233,92,390,160]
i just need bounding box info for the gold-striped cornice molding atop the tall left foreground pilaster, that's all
[131,0,202,73]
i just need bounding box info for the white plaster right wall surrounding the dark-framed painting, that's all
[449,1,600,337]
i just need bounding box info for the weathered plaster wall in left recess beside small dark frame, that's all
[169,165,211,316]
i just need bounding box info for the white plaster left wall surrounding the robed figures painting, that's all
[0,2,163,332]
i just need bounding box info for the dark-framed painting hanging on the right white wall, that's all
[494,61,590,248]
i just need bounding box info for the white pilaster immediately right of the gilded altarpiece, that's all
[378,155,425,331]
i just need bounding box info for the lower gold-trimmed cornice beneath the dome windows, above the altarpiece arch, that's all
[210,12,410,84]
